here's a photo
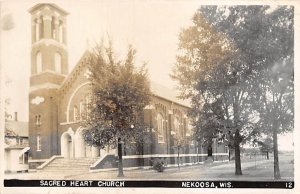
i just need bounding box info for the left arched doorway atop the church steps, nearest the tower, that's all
[60,131,73,158]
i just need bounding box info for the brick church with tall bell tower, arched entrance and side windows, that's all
[29,4,228,169]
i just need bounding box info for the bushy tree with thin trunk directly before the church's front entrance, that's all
[84,42,150,175]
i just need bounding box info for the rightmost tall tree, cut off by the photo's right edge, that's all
[201,6,294,179]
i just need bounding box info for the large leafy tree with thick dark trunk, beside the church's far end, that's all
[171,11,257,175]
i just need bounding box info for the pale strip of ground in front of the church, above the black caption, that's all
[5,155,294,181]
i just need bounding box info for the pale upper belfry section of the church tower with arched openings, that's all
[29,4,68,82]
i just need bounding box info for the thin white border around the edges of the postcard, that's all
[0,0,300,194]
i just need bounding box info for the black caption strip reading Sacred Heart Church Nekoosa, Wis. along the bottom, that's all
[4,179,294,189]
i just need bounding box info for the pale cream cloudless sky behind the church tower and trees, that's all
[1,0,292,149]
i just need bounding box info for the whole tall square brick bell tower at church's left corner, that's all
[29,3,68,161]
